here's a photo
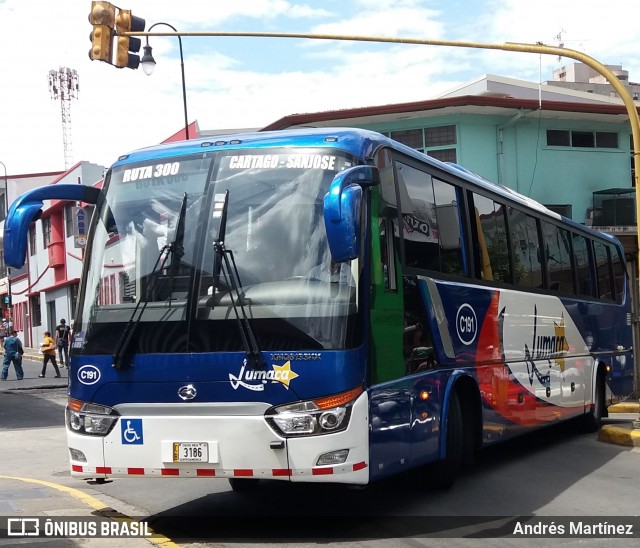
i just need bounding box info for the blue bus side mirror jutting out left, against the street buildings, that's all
[4,183,102,268]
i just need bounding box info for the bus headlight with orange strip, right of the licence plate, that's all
[265,387,362,437]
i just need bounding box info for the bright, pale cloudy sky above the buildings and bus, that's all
[0,0,640,176]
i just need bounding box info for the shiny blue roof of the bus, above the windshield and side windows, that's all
[112,127,617,245]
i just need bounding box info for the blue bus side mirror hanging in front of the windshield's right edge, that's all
[324,166,380,263]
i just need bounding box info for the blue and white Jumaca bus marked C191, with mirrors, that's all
[5,128,633,490]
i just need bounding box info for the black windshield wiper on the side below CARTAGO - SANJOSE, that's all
[212,190,264,369]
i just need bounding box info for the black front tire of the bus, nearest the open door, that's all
[428,391,465,489]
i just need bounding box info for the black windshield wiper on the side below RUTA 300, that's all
[111,192,187,369]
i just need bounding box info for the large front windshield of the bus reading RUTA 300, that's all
[74,148,363,354]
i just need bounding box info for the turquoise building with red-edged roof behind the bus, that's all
[264,75,640,257]
